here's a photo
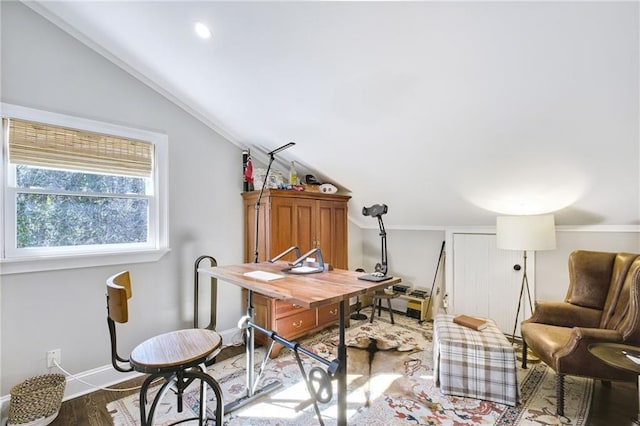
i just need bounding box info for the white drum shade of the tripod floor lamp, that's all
[496,214,556,250]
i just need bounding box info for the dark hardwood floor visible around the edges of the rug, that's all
[51,346,638,426]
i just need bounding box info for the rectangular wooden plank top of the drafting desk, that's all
[198,262,402,309]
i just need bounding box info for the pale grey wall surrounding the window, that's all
[0,2,242,395]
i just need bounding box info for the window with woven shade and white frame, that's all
[2,104,168,273]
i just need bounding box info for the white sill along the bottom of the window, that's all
[0,248,170,275]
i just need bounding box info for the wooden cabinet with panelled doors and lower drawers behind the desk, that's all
[242,189,350,357]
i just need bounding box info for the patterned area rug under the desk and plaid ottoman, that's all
[107,312,593,426]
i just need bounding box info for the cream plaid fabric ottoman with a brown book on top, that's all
[433,314,520,406]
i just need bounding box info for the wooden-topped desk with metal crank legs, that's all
[198,262,402,426]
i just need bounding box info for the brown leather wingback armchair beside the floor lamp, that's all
[521,250,640,415]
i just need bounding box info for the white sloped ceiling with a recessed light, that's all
[26,1,640,229]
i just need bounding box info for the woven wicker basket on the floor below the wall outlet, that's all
[8,374,67,425]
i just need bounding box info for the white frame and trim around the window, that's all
[0,103,170,275]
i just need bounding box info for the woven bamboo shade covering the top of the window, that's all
[8,118,154,177]
